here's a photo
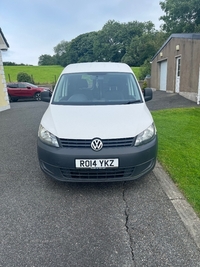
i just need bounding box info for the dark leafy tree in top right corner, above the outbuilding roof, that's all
[160,0,200,34]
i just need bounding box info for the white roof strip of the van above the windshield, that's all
[62,62,133,74]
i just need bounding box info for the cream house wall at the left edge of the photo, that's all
[0,50,10,111]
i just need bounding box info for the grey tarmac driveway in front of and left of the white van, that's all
[0,96,200,267]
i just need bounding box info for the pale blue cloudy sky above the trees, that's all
[0,0,163,65]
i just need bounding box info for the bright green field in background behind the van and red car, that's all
[4,66,140,84]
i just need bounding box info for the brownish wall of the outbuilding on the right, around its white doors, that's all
[151,38,200,101]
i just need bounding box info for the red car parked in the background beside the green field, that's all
[7,82,50,102]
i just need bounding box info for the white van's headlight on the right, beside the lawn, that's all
[135,123,156,146]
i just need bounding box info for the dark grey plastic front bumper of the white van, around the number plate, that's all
[37,135,158,182]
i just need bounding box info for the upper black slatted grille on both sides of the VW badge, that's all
[60,137,135,148]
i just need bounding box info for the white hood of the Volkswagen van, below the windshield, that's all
[41,103,153,139]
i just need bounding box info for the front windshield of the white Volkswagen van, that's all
[52,72,142,105]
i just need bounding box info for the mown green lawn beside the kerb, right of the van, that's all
[152,108,200,216]
